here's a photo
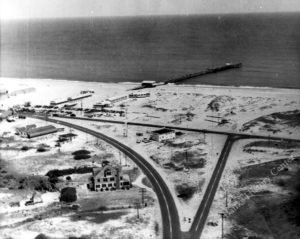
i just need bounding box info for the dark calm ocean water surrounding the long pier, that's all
[0,13,300,88]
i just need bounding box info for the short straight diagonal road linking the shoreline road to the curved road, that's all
[186,135,238,239]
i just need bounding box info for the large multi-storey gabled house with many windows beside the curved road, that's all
[88,165,131,191]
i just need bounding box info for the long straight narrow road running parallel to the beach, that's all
[47,116,300,142]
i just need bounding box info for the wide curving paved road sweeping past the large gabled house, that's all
[31,116,181,239]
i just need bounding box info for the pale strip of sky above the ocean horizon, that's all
[0,0,300,19]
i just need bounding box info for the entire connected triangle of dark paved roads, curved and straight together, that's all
[28,115,300,239]
